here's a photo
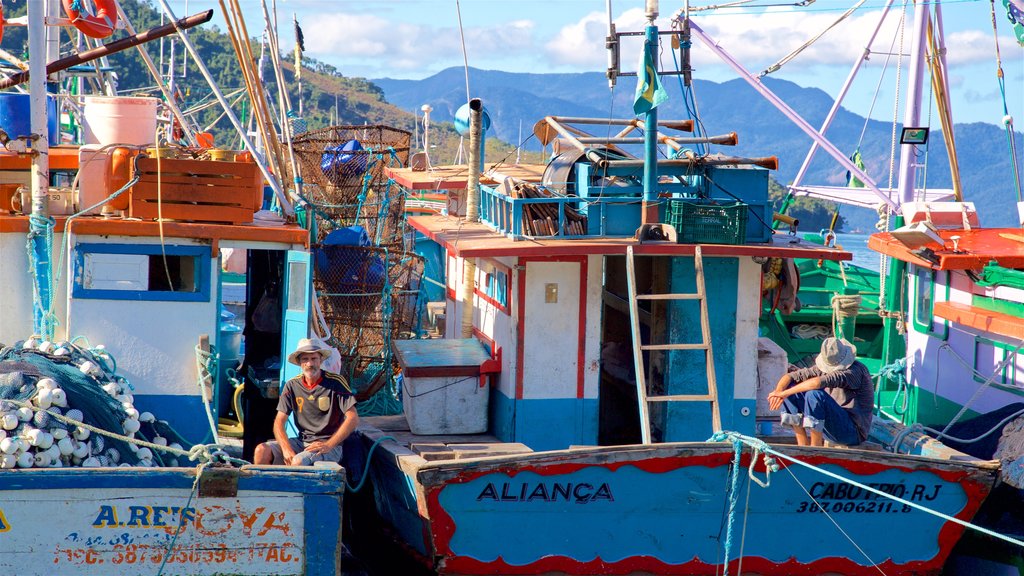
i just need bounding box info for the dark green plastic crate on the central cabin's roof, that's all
[668,200,748,244]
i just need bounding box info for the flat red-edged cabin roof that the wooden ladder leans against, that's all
[409,215,853,260]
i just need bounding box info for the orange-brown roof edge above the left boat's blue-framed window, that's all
[0,215,309,251]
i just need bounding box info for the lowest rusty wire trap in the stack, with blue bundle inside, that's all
[313,245,424,413]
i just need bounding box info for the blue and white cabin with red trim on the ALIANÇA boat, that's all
[389,140,851,450]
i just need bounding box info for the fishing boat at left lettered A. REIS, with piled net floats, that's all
[0,0,345,575]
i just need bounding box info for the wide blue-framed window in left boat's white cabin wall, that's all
[72,244,210,302]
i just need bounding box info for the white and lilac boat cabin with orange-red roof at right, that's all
[868,202,1024,425]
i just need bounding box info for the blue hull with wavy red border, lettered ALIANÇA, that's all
[356,434,995,574]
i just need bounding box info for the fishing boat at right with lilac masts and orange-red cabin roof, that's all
[688,2,1024,574]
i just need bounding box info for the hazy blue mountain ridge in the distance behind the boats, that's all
[372,68,1024,232]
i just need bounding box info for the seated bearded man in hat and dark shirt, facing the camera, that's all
[253,338,359,466]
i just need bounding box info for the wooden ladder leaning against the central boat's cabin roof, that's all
[626,245,722,444]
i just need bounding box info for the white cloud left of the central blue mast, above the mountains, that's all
[302,12,534,74]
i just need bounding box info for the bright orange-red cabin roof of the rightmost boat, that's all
[867,228,1024,270]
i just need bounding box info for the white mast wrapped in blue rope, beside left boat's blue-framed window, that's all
[28,1,53,339]
